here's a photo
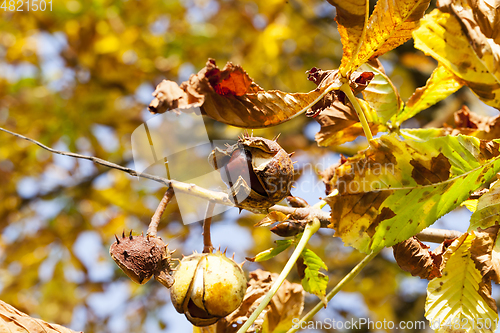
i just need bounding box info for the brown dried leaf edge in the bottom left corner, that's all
[0,301,80,333]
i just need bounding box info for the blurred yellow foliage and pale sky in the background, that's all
[0,0,495,333]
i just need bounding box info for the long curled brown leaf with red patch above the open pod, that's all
[149,59,326,128]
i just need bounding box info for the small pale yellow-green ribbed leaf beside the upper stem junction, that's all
[359,64,403,123]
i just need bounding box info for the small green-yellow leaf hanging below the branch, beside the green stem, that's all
[301,249,328,307]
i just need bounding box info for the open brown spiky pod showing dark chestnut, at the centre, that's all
[208,135,293,209]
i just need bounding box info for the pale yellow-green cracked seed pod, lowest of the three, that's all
[170,252,247,326]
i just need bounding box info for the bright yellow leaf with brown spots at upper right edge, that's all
[413,9,500,107]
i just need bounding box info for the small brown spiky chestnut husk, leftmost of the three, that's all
[109,231,174,288]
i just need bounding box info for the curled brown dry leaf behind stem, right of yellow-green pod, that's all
[217,269,304,333]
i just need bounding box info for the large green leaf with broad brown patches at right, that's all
[325,134,500,253]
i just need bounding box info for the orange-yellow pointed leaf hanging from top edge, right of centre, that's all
[329,0,430,76]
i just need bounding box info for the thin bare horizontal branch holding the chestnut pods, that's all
[0,127,461,243]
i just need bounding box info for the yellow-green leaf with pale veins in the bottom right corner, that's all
[425,234,498,332]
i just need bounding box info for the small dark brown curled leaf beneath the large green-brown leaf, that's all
[392,237,453,280]
